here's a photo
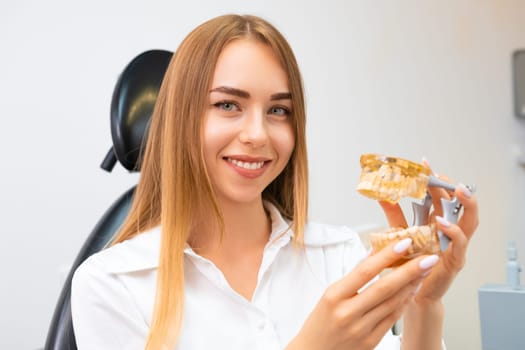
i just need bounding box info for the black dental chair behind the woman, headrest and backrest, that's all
[45,50,172,350]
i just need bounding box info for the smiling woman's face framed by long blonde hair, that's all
[203,39,295,203]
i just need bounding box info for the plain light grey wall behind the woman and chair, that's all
[0,0,525,350]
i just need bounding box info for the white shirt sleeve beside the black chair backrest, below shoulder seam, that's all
[71,257,149,350]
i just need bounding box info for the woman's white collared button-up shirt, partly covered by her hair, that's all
[71,206,400,350]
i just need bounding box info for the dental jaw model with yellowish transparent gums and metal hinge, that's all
[357,154,473,266]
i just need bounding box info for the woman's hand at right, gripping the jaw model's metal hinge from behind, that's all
[380,176,479,303]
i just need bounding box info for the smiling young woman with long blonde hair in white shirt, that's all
[72,15,478,350]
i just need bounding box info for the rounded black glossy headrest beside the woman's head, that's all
[101,50,173,171]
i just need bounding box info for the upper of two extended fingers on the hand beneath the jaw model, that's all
[325,238,418,302]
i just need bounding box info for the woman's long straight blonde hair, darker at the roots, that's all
[113,15,308,349]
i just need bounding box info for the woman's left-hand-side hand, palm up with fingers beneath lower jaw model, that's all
[286,238,438,350]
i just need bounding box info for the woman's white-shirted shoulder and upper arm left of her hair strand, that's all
[71,231,154,349]
